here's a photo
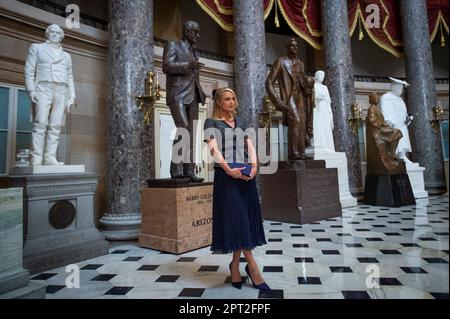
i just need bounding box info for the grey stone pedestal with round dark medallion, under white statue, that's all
[3,173,108,274]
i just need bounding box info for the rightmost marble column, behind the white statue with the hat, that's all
[400,0,447,195]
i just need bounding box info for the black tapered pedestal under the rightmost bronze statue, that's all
[364,174,416,207]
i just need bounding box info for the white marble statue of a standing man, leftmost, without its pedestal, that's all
[25,24,75,166]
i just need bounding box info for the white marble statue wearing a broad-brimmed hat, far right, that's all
[380,77,412,164]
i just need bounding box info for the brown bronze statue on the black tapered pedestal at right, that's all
[366,93,406,175]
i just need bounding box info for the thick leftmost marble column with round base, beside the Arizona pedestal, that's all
[100,0,154,240]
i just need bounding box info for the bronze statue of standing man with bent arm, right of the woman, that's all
[266,38,315,160]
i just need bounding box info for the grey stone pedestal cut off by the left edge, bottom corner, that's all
[0,188,45,299]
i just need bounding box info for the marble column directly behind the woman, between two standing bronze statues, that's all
[233,0,267,129]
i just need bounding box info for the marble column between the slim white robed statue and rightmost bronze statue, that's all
[321,0,363,195]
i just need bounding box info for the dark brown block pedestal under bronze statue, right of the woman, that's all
[261,160,342,224]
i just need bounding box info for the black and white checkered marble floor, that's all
[32,196,449,299]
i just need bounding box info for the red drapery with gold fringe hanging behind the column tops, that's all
[196,0,449,57]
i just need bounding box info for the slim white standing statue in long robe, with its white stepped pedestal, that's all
[312,70,357,208]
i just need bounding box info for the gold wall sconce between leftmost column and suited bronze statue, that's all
[135,71,161,125]
